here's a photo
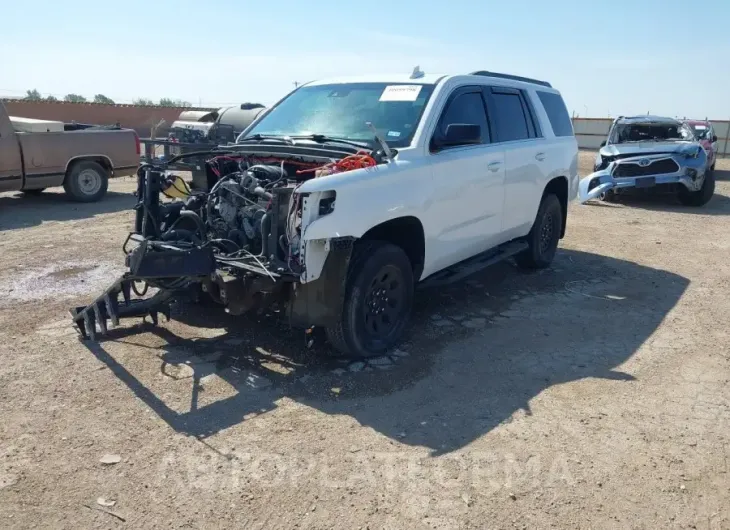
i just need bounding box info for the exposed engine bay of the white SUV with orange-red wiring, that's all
[155,146,377,274]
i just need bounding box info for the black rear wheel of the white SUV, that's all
[515,194,563,269]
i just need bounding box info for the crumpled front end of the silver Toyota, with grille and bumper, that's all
[578,144,707,203]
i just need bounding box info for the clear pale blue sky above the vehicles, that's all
[0,0,730,119]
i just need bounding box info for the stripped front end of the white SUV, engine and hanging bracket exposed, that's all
[71,141,388,340]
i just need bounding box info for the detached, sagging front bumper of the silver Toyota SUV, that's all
[578,157,705,203]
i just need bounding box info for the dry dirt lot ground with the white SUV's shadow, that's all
[0,153,730,529]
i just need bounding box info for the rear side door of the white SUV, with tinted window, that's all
[485,86,548,235]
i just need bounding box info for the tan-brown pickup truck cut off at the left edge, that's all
[0,102,140,202]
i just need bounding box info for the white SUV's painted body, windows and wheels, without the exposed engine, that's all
[270,68,578,356]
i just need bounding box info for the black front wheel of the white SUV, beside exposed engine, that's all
[326,241,414,357]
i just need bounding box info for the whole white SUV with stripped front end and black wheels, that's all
[72,70,578,356]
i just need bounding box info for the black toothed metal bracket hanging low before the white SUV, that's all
[70,272,173,340]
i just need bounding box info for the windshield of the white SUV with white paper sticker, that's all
[239,83,433,147]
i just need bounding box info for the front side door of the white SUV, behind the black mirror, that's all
[428,86,504,270]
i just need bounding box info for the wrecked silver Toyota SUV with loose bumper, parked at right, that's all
[580,116,715,206]
